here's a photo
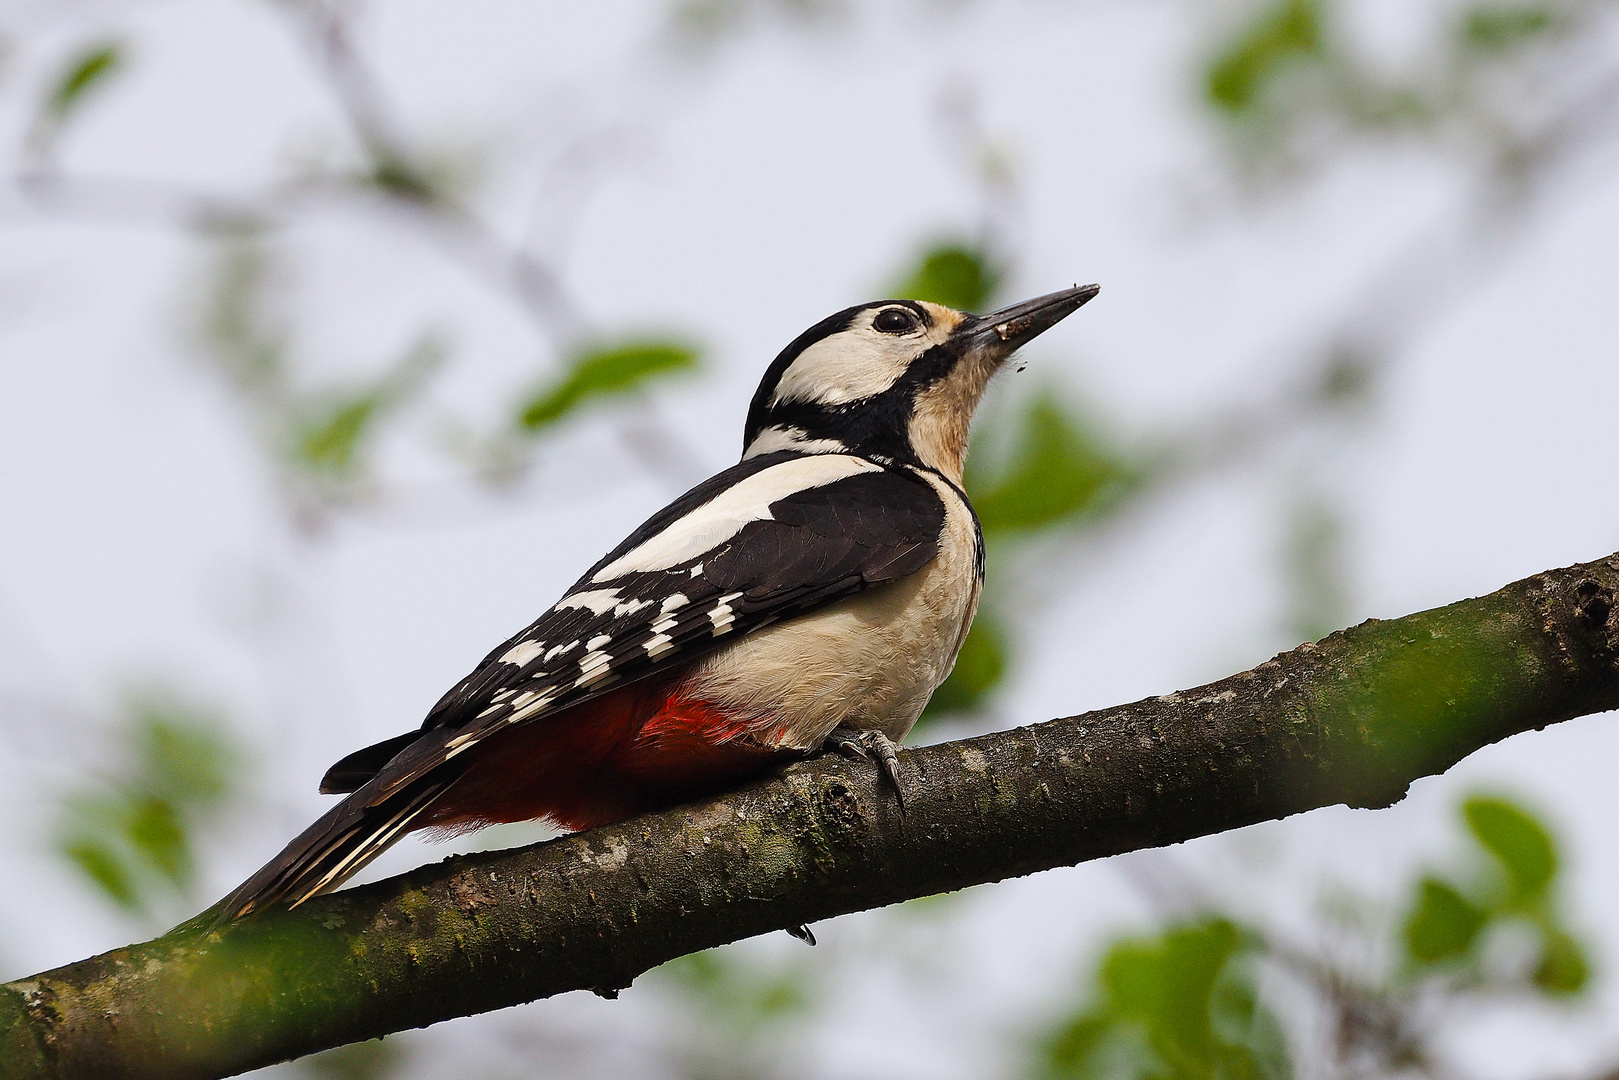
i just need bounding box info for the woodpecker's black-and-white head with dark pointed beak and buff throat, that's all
[742,285,1098,483]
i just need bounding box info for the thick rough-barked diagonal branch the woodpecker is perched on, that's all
[0,555,1619,1080]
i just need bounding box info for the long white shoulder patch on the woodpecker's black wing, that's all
[589,453,882,582]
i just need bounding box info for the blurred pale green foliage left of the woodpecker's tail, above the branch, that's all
[57,698,238,912]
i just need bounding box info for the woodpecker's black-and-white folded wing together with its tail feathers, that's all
[217,453,944,920]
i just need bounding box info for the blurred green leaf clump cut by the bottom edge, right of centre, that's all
[1035,918,1290,1080]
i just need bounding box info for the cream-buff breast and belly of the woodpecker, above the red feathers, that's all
[686,473,981,750]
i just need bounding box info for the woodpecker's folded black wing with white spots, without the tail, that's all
[334,452,944,798]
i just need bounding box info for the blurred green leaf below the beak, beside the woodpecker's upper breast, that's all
[967,392,1140,534]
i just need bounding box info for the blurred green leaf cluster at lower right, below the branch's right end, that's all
[1404,795,1590,997]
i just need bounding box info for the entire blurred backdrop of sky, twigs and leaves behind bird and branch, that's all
[0,0,1619,1080]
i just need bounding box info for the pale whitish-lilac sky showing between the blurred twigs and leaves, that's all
[0,0,1619,1080]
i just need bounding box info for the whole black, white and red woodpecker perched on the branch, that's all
[220,285,1098,918]
